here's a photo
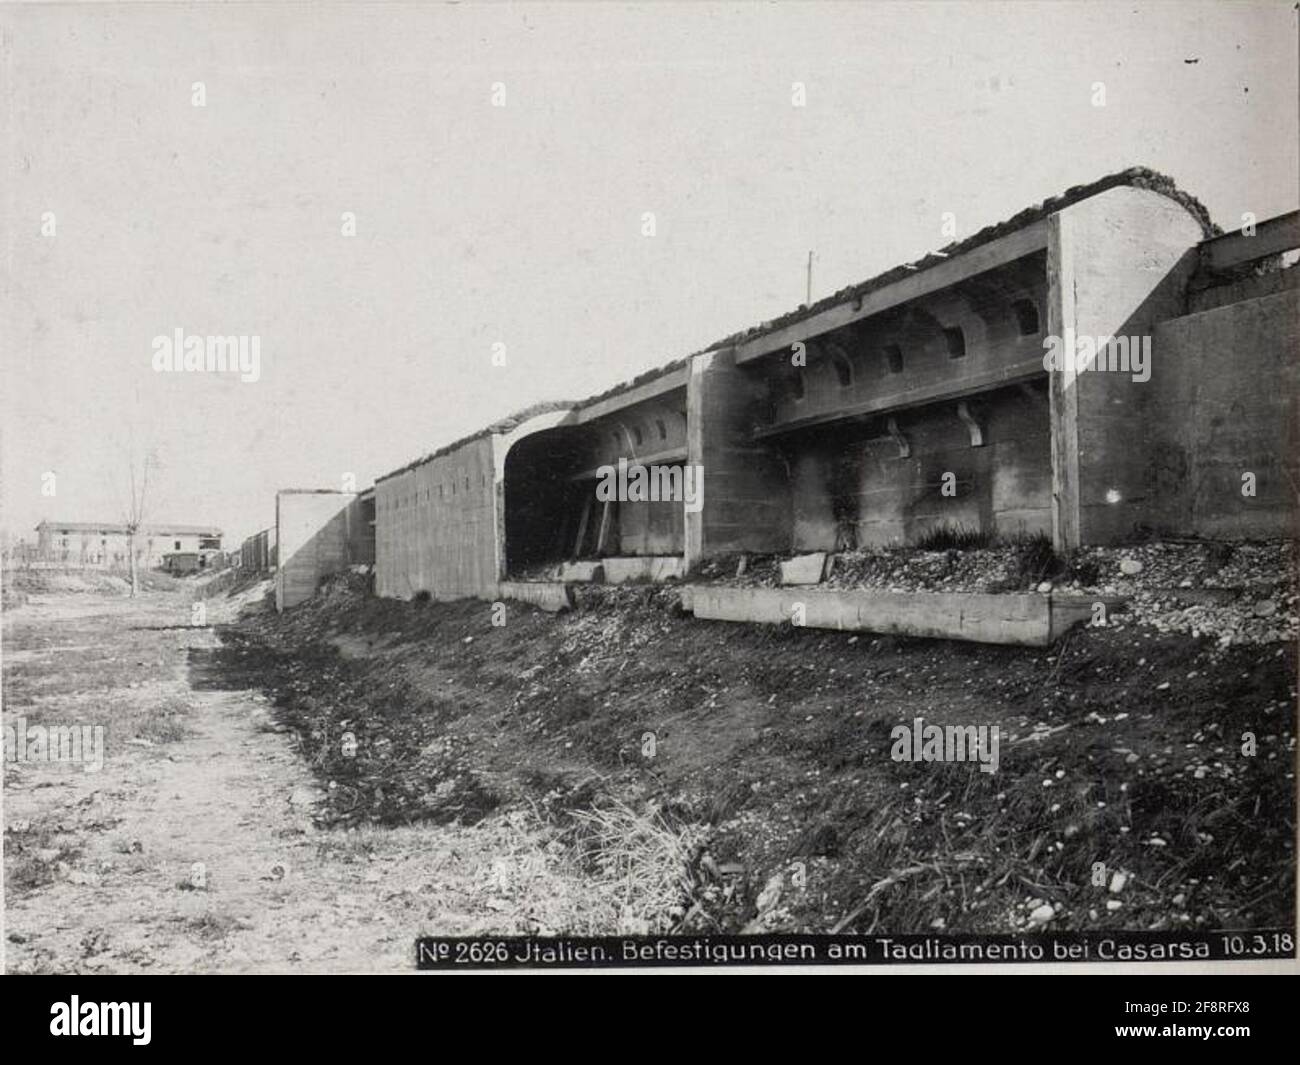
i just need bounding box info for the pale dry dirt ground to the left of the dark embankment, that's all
[4,596,533,973]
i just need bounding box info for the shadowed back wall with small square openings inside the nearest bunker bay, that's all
[745,250,1052,551]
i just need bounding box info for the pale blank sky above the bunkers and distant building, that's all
[0,0,1300,546]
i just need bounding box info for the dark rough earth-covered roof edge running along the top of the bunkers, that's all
[374,166,1223,484]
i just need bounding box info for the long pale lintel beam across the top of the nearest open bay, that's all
[736,216,1054,365]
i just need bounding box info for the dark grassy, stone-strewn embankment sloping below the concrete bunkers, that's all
[222,576,1296,932]
